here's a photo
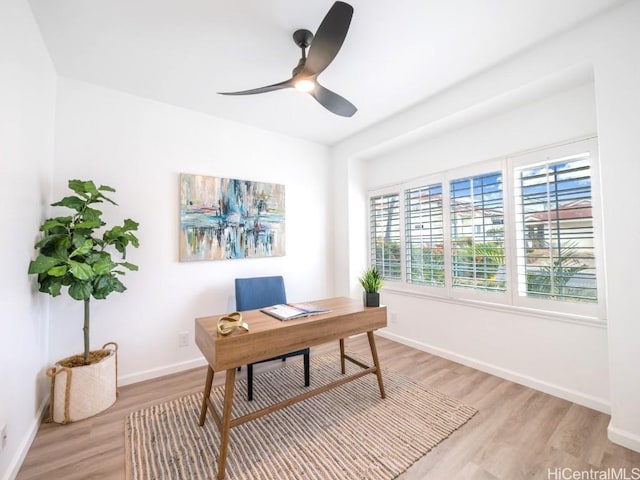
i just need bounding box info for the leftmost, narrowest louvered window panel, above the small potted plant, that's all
[369,194,401,279]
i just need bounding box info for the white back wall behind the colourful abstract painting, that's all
[49,78,333,383]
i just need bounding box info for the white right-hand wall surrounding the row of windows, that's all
[333,0,640,451]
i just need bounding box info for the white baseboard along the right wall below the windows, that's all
[376,330,611,414]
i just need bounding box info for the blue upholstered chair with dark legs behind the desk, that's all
[236,276,310,401]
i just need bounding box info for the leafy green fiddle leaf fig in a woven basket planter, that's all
[29,180,139,423]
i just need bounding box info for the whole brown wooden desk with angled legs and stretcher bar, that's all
[196,297,387,480]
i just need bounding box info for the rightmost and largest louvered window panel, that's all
[514,152,598,302]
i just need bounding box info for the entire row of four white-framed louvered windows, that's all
[370,139,604,319]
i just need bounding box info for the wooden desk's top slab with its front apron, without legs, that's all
[195,297,387,371]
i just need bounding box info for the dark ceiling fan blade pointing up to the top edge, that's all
[303,2,353,75]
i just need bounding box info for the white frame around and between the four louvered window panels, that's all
[367,135,606,324]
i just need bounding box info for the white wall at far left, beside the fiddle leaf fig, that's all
[0,0,56,479]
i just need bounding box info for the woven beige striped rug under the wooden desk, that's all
[125,354,476,480]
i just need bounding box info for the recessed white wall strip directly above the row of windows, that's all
[366,81,597,190]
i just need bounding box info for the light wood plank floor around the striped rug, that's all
[17,337,640,480]
